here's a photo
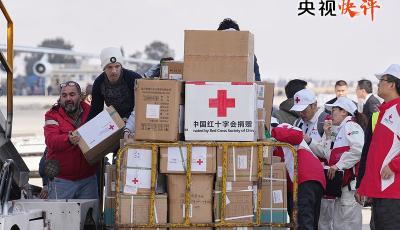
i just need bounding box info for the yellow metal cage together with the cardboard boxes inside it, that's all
[108,141,297,229]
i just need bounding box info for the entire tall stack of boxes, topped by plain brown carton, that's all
[101,31,286,229]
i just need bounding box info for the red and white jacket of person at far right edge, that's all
[358,98,400,199]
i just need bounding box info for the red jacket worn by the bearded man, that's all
[44,102,98,180]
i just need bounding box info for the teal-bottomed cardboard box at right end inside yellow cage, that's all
[261,163,287,223]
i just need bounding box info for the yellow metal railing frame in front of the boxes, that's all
[114,141,298,229]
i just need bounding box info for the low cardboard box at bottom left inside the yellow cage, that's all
[119,194,167,229]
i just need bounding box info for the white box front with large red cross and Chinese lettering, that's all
[185,82,257,141]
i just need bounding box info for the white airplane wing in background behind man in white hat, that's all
[0,44,160,65]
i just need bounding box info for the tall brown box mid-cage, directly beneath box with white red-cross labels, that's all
[168,174,214,223]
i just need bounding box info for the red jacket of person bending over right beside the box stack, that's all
[272,125,326,189]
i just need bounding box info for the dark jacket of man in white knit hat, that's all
[88,69,142,120]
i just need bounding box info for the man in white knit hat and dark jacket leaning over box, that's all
[88,47,142,120]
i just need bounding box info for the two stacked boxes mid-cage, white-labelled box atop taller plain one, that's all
[160,146,217,229]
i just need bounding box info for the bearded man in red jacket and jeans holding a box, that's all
[44,81,98,199]
